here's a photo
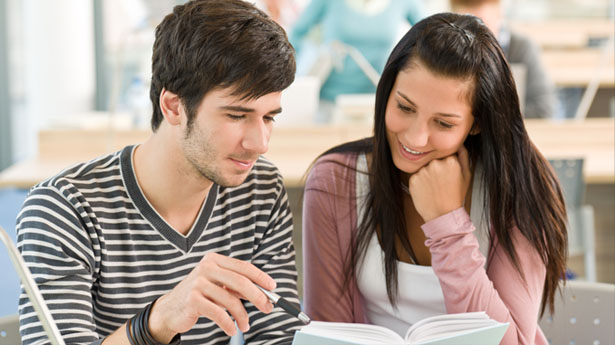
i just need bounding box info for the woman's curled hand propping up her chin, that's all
[408,145,472,222]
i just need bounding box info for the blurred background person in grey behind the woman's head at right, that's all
[450,0,557,118]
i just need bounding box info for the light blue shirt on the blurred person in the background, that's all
[290,0,424,101]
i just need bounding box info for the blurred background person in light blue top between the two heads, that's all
[290,0,424,122]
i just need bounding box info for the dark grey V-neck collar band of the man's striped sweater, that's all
[120,145,218,252]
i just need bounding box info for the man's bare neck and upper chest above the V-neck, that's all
[132,129,213,235]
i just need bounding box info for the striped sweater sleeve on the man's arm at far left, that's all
[17,187,100,345]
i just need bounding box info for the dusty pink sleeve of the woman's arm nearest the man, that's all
[302,156,357,322]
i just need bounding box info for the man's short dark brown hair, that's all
[150,0,295,131]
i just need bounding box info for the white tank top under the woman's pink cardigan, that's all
[356,155,488,337]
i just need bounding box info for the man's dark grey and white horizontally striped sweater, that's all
[17,146,300,344]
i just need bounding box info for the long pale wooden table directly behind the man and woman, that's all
[0,118,615,188]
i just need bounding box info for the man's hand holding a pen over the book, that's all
[149,253,276,343]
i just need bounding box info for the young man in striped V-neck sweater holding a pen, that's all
[17,0,299,345]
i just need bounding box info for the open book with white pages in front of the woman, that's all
[293,312,508,345]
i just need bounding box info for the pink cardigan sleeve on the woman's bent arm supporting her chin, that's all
[423,208,546,344]
